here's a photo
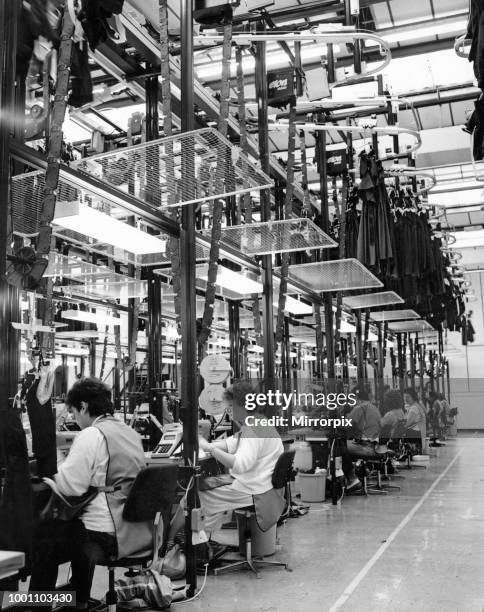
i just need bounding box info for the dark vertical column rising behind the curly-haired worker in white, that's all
[255,21,275,390]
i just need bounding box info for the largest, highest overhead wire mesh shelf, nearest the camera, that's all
[73,128,272,210]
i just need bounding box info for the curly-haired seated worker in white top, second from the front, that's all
[167,382,284,550]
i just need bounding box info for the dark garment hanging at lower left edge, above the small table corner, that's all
[0,406,33,565]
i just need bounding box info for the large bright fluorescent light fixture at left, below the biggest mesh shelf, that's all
[53,201,166,255]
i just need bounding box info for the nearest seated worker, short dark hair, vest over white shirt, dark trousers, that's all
[29,378,152,609]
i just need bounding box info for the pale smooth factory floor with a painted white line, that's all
[88,434,484,612]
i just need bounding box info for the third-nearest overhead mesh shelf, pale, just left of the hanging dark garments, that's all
[282,259,383,292]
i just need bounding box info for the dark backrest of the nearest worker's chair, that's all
[123,464,178,523]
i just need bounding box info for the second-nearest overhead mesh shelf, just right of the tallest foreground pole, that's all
[204,219,337,257]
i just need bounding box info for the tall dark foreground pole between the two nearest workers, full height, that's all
[180,0,198,597]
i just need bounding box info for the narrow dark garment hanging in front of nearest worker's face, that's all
[26,379,57,477]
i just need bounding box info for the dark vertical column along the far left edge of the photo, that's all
[0,0,21,416]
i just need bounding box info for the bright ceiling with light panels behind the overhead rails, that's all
[25,0,484,266]
